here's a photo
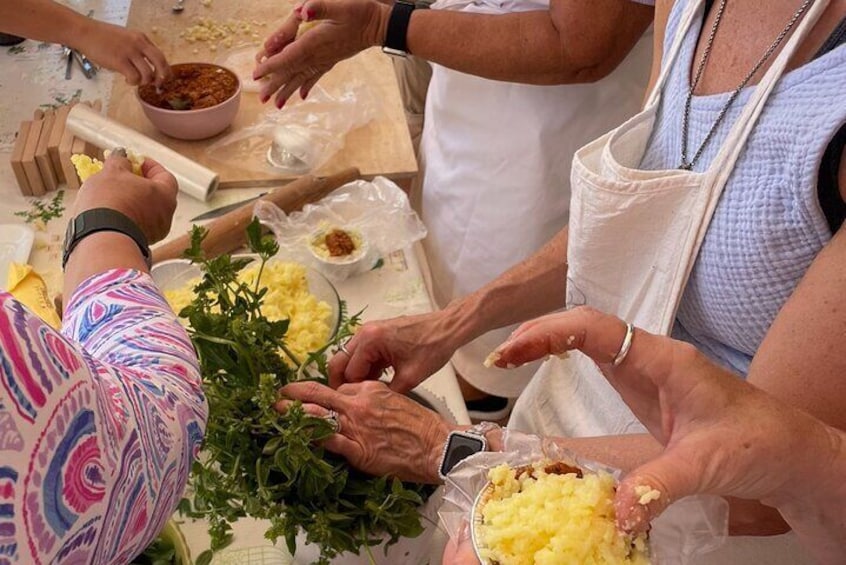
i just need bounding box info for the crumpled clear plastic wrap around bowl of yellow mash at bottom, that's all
[438,430,728,565]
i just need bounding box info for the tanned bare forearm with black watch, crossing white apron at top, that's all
[407,0,652,84]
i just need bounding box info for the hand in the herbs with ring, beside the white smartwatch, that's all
[276,382,450,483]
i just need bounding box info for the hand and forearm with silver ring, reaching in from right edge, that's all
[486,307,846,563]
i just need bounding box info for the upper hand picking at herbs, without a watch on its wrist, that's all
[329,312,456,393]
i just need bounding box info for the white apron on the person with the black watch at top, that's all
[421,0,651,397]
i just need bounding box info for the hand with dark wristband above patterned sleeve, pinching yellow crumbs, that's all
[71,155,177,244]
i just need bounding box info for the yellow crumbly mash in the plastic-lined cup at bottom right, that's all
[476,464,649,565]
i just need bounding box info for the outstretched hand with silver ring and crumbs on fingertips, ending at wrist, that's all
[486,307,824,531]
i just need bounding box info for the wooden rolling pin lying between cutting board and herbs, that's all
[153,168,360,263]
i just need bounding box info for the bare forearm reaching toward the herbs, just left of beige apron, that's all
[443,228,567,343]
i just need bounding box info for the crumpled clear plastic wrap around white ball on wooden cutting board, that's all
[208,83,376,174]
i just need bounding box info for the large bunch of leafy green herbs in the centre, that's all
[180,221,429,563]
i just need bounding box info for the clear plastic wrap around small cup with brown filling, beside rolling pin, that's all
[254,177,426,281]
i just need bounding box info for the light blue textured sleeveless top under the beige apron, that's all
[641,0,846,376]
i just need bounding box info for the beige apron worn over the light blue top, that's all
[510,0,828,437]
